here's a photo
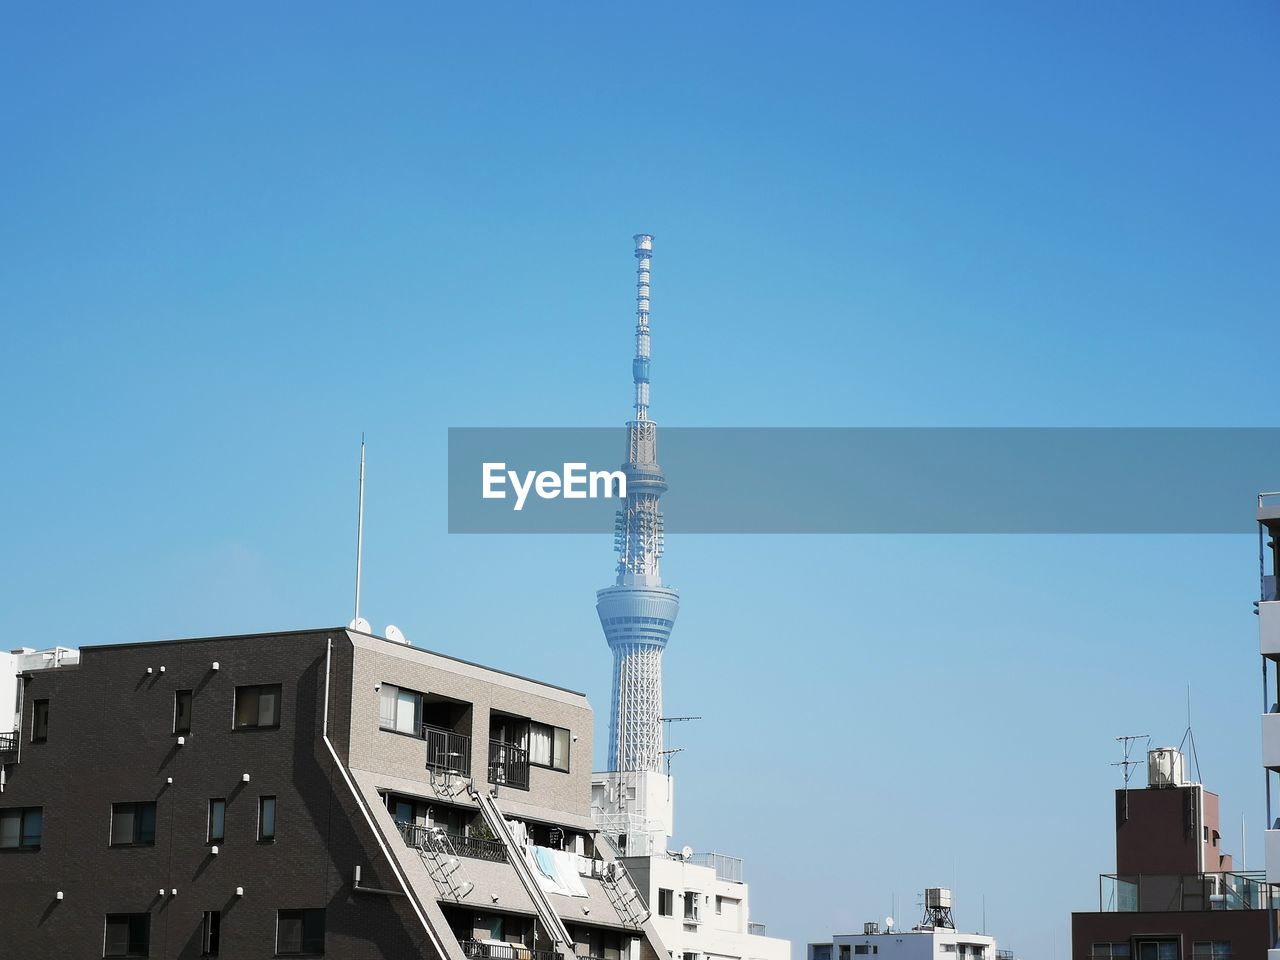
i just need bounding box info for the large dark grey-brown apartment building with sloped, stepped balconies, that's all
[0,627,667,960]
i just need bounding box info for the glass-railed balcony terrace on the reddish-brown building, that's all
[1098,870,1280,913]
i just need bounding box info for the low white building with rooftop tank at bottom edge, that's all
[808,887,1012,960]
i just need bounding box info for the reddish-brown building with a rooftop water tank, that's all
[1071,748,1280,960]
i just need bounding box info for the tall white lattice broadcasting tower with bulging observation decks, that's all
[595,233,680,773]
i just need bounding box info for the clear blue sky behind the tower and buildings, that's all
[0,0,1280,959]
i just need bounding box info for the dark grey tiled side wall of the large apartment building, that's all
[0,630,436,960]
